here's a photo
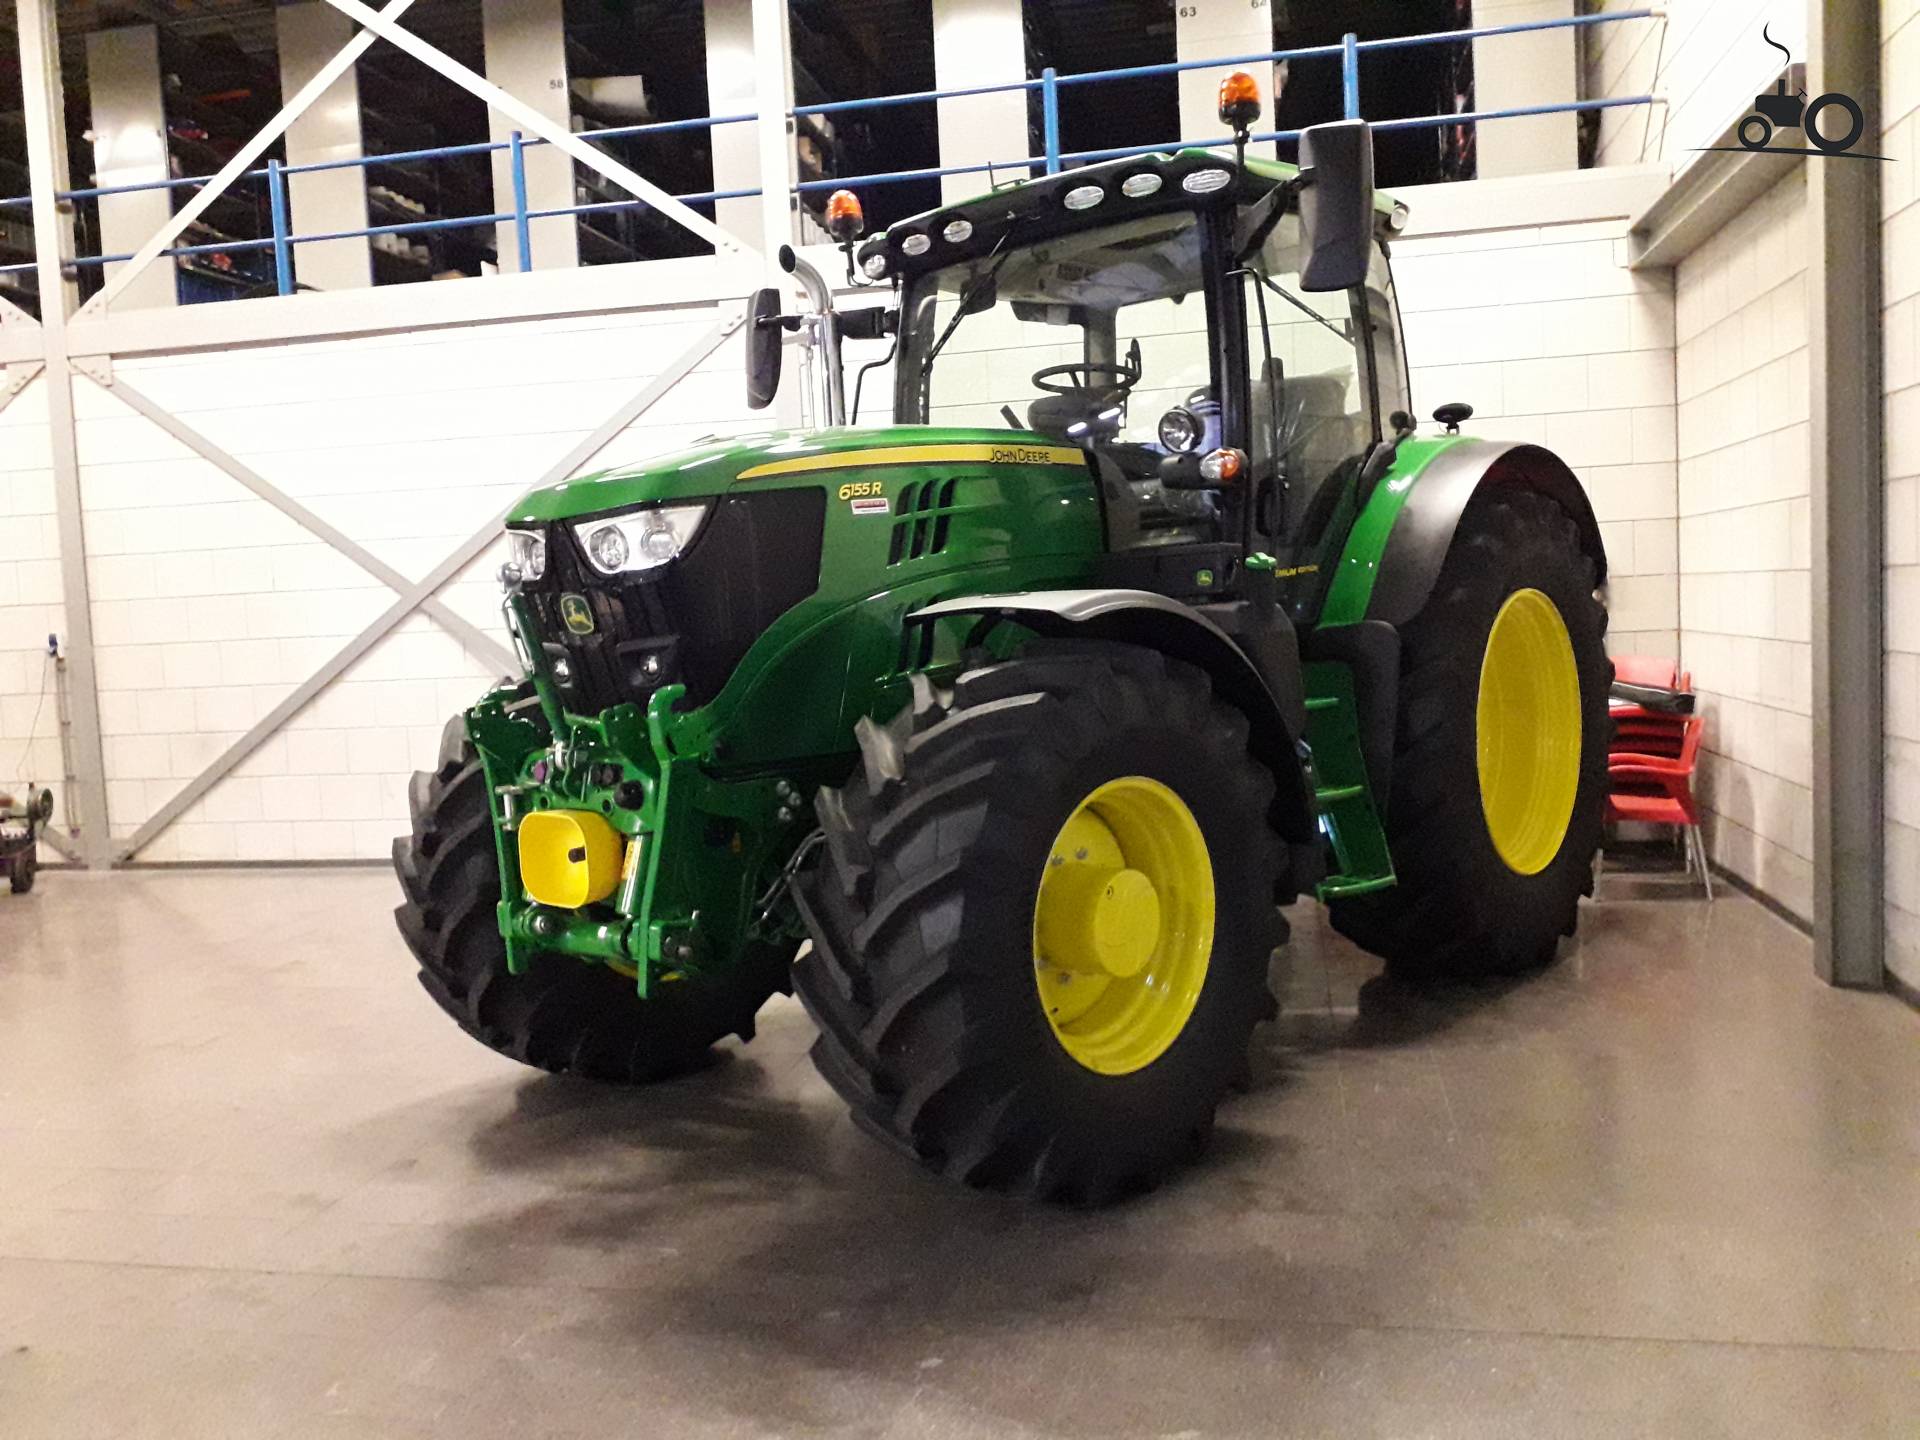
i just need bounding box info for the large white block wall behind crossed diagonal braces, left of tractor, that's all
[60,311,768,860]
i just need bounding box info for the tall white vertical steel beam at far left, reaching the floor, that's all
[15,0,111,866]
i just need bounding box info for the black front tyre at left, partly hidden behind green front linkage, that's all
[394,716,799,1085]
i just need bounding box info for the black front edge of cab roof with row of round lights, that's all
[858,148,1407,280]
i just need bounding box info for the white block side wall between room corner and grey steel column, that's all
[1676,169,1812,916]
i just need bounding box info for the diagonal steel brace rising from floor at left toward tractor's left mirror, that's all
[113,317,745,862]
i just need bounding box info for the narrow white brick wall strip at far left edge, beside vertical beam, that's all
[0,376,67,860]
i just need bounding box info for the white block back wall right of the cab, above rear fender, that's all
[1394,221,1678,655]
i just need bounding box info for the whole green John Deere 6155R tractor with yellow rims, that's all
[394,96,1611,1204]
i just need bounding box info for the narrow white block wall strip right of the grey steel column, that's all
[1880,0,1920,989]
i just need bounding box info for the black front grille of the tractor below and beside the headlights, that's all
[528,488,826,714]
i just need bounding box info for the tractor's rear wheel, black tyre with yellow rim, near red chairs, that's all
[1329,490,1613,979]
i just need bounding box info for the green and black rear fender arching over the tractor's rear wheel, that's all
[1319,436,1607,626]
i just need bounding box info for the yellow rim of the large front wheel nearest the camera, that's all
[1033,776,1213,1075]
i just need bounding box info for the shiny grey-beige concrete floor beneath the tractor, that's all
[0,872,1920,1440]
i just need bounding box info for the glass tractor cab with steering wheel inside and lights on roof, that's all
[858,123,1411,620]
